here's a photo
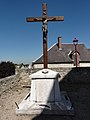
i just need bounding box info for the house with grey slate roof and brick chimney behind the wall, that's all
[32,37,90,68]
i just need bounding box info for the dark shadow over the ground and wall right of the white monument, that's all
[32,67,90,120]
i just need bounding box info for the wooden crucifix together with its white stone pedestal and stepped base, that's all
[16,3,73,115]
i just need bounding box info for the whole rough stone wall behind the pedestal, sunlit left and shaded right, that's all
[0,67,90,94]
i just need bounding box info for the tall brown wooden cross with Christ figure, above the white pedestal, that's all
[26,3,64,68]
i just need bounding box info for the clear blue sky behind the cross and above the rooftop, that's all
[0,0,90,64]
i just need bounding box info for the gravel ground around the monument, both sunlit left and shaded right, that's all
[0,81,90,120]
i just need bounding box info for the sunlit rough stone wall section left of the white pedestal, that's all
[0,69,30,95]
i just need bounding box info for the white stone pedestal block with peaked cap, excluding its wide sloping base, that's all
[30,69,61,103]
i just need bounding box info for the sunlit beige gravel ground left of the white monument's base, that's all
[0,87,35,120]
